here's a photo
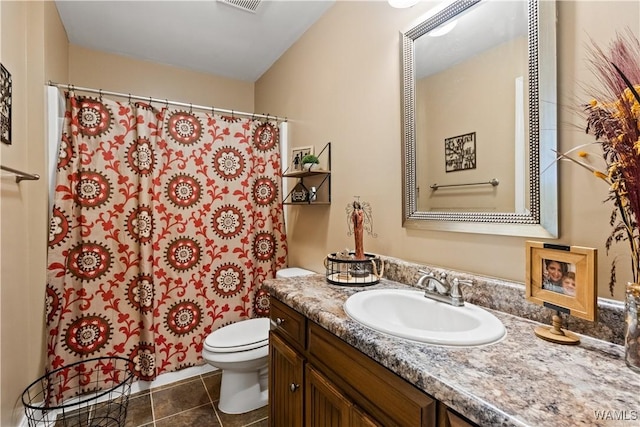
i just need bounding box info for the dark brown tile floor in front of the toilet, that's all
[125,371,268,427]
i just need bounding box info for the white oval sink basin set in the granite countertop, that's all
[344,289,506,346]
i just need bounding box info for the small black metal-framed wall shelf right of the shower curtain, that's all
[282,142,331,205]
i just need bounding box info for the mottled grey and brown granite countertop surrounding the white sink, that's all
[263,274,640,427]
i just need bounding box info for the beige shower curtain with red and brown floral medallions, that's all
[46,93,287,401]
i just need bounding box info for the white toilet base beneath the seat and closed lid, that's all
[218,368,269,414]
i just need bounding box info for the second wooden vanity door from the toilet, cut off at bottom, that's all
[304,364,353,427]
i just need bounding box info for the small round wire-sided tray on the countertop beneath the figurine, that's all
[324,251,384,286]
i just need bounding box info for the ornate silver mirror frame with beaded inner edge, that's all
[401,0,558,238]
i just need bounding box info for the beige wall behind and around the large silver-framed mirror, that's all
[256,1,640,299]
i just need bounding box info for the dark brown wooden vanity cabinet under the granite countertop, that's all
[269,297,438,427]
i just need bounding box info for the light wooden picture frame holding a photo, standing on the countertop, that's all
[525,241,597,321]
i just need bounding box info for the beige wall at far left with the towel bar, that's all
[0,1,67,426]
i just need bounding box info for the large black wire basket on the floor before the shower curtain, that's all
[22,357,134,427]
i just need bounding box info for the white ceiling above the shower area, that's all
[56,0,334,82]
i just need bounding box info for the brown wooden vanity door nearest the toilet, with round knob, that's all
[269,332,304,427]
